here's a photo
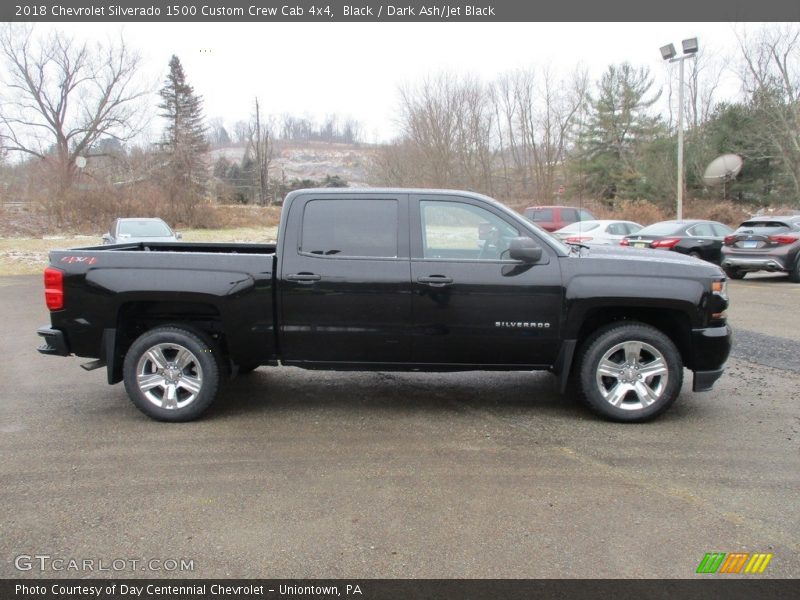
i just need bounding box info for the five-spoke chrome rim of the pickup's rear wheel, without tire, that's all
[136,343,203,410]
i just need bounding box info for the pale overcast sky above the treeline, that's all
[37,22,756,142]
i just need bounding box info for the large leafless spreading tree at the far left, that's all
[0,24,149,193]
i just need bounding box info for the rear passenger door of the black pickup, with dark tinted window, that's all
[279,193,411,366]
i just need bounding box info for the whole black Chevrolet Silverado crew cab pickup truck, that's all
[38,189,731,421]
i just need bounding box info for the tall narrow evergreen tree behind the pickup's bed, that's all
[158,55,208,214]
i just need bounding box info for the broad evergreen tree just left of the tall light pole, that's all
[580,63,663,198]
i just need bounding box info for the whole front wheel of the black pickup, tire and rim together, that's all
[579,323,683,422]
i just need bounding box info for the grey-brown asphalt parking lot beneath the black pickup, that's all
[0,276,800,578]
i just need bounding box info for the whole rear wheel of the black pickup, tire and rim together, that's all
[123,327,220,422]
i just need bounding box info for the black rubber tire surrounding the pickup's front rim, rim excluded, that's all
[579,323,683,423]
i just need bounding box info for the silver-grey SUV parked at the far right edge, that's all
[722,215,800,283]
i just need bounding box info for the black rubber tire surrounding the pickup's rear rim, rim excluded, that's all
[123,327,220,422]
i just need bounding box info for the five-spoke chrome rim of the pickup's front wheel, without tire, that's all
[595,340,669,411]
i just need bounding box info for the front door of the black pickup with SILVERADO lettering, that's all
[410,194,562,367]
